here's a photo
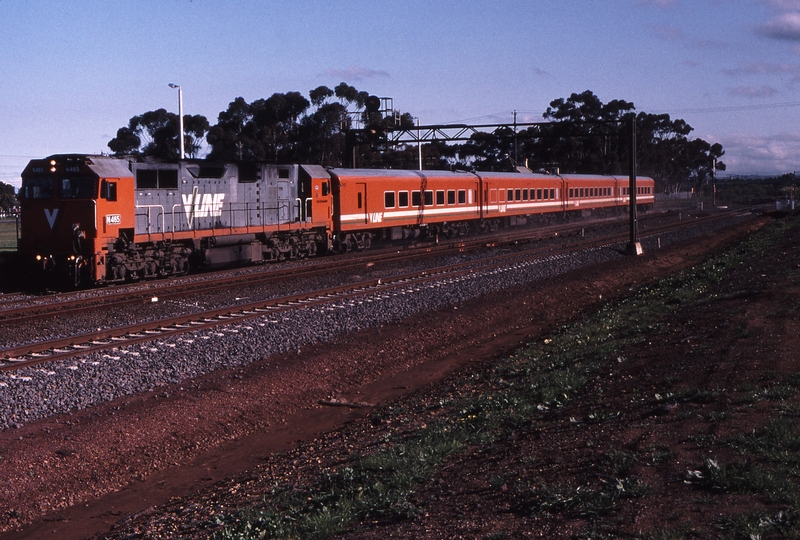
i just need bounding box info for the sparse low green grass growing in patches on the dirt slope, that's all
[209,215,800,540]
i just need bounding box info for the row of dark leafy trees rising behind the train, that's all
[108,82,725,191]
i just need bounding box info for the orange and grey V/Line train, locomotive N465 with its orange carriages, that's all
[19,154,654,287]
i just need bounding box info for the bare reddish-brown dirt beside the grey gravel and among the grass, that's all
[0,212,800,539]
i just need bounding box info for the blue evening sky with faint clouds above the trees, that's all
[0,0,800,187]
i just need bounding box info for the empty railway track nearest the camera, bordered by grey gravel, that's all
[0,206,756,371]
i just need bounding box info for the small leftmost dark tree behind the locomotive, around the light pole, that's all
[108,109,209,159]
